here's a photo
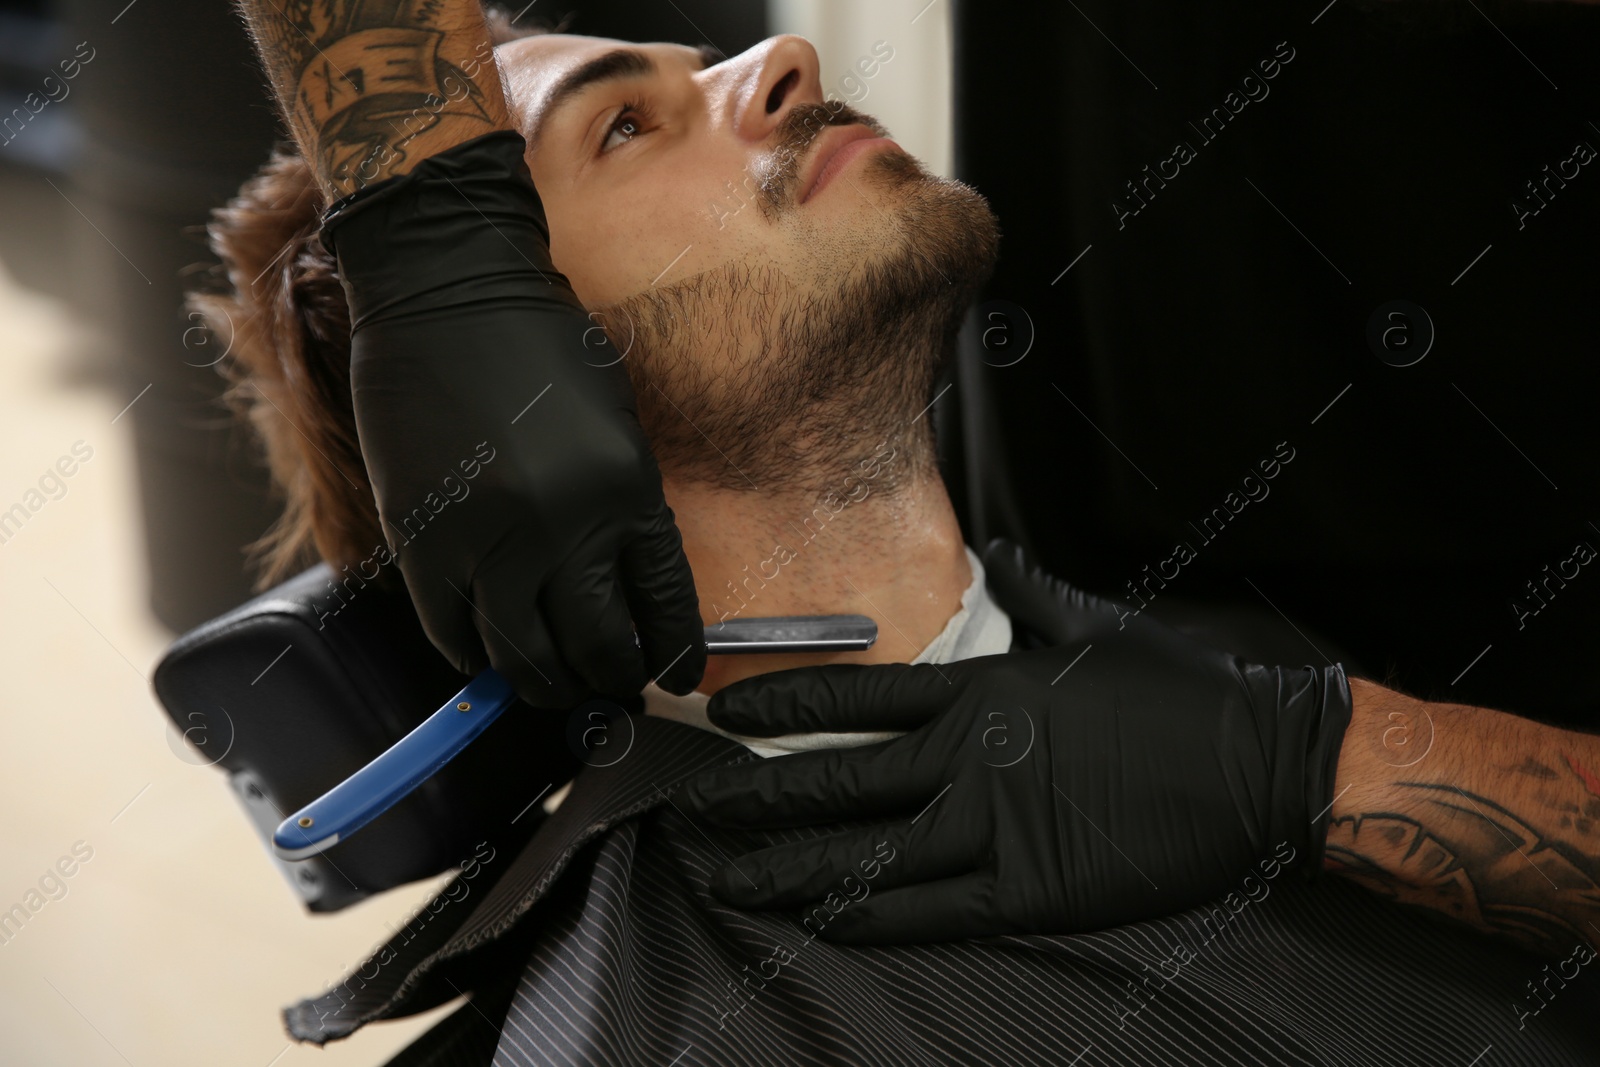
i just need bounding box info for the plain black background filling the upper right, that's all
[946,0,1600,721]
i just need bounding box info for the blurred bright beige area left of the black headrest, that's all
[0,259,460,1067]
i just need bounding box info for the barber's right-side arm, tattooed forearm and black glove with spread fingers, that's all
[685,542,1600,955]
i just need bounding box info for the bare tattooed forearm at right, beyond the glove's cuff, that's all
[1325,681,1600,958]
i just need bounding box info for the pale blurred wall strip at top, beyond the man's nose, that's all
[766,0,950,176]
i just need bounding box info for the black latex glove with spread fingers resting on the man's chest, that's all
[682,544,1350,944]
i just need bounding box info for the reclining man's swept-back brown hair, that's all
[189,11,552,589]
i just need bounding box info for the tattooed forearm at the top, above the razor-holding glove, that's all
[240,0,507,197]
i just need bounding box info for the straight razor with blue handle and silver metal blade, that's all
[272,614,878,859]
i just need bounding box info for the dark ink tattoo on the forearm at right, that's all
[1325,709,1600,957]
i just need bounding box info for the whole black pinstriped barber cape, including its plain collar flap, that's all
[285,614,1600,1067]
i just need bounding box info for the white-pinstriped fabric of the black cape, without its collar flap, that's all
[493,751,1600,1067]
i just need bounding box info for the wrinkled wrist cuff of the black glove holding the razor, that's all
[322,130,582,334]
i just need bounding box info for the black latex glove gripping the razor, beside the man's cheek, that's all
[323,131,706,707]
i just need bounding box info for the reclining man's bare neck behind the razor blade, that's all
[664,464,973,696]
